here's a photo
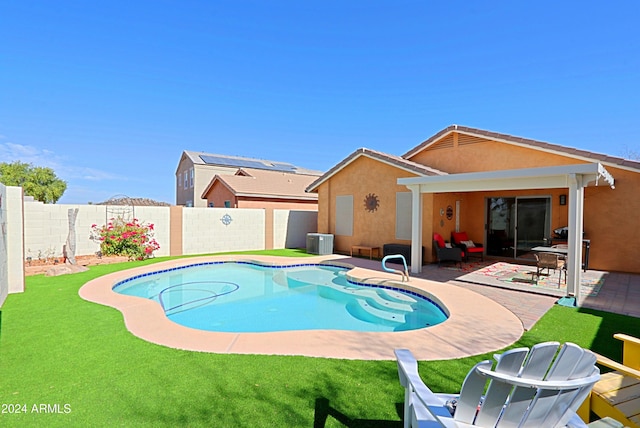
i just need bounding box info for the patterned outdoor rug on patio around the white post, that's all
[457,262,607,297]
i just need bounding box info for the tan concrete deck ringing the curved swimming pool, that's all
[79,255,524,360]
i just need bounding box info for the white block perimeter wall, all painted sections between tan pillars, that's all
[0,197,318,305]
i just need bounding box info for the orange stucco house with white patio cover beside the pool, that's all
[307,125,640,282]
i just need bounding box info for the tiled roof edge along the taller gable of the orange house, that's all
[402,125,640,170]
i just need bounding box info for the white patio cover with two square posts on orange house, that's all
[397,163,615,302]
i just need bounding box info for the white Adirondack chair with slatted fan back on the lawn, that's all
[395,342,600,428]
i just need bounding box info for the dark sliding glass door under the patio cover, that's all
[487,197,551,258]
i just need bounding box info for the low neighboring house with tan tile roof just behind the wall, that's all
[201,168,319,211]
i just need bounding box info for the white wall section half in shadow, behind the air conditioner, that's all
[273,210,318,249]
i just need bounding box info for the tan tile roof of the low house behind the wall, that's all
[202,168,318,200]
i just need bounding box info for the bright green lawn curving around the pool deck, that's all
[0,251,640,427]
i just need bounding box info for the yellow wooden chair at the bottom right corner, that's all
[578,333,640,428]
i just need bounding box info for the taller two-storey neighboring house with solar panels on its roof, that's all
[176,151,321,207]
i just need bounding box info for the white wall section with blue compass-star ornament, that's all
[182,208,265,254]
